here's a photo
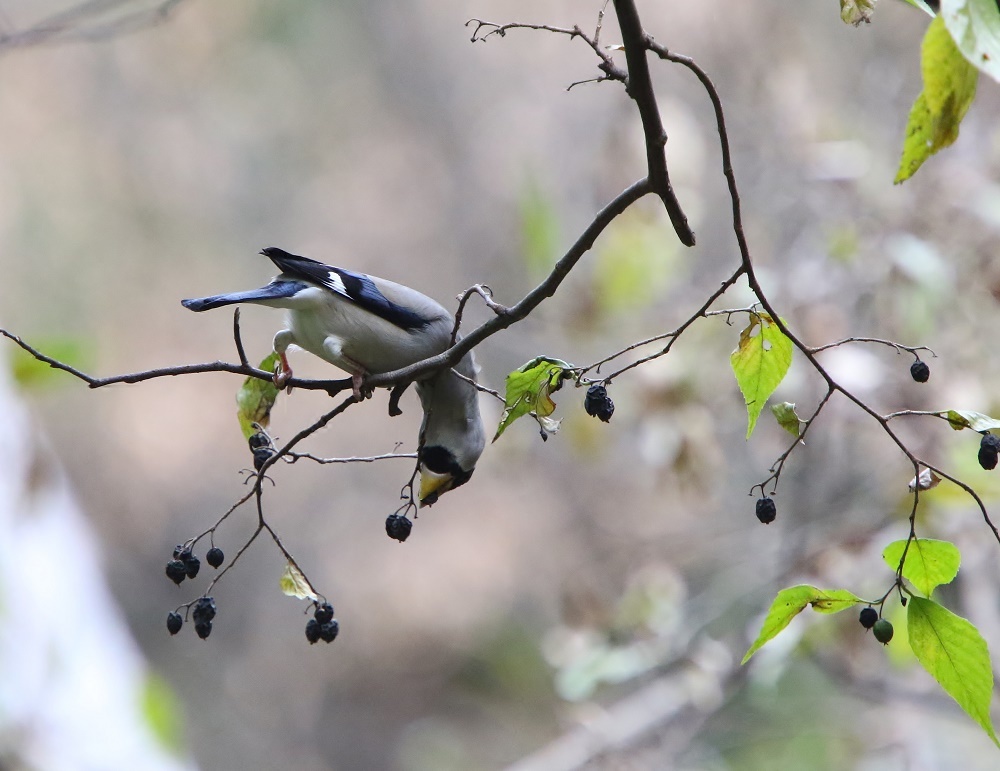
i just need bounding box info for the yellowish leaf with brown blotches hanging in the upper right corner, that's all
[895,17,979,184]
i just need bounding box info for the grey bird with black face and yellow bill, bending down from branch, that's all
[181,246,486,505]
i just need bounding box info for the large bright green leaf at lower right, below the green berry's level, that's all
[906,597,1000,747]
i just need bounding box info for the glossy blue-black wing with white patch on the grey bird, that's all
[261,246,447,331]
